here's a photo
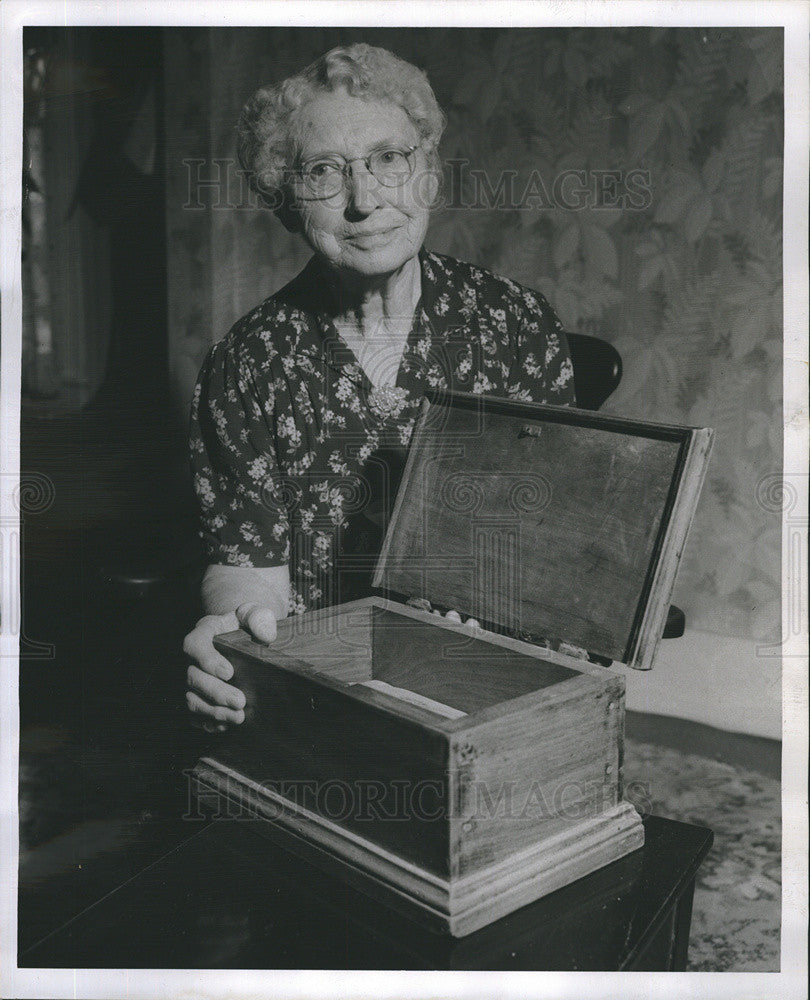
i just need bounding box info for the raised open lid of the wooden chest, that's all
[374,393,713,670]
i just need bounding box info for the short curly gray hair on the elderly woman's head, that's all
[236,42,446,209]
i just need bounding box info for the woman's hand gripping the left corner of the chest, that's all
[183,603,276,733]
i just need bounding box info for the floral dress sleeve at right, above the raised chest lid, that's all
[509,288,576,406]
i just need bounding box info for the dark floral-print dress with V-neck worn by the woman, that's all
[191,250,574,613]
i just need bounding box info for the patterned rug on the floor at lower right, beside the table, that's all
[624,738,781,972]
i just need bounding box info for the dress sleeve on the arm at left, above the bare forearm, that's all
[189,341,289,568]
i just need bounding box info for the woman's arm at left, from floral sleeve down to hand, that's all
[183,331,290,730]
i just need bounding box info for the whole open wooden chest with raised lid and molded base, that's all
[195,394,712,936]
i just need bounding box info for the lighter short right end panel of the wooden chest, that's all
[451,673,624,875]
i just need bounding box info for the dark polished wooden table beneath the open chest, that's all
[19,817,713,971]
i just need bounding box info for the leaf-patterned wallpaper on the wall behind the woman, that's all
[165,28,783,642]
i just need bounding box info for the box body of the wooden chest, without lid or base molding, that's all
[205,599,624,906]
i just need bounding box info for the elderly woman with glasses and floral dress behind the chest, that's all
[184,44,573,730]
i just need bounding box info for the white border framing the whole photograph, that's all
[0,0,810,1000]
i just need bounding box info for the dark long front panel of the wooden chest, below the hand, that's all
[211,639,449,874]
